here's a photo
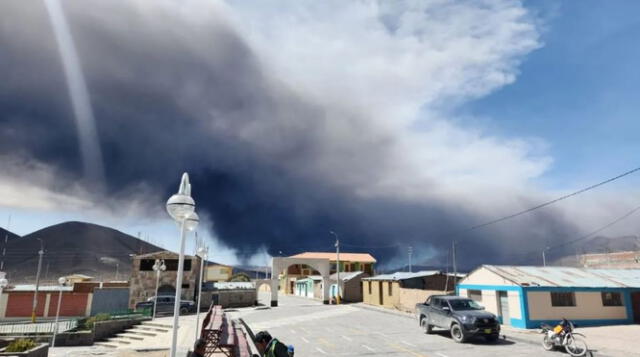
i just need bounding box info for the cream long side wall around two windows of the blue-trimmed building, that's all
[527,291,627,320]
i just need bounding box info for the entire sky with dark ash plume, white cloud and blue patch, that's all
[0,0,640,266]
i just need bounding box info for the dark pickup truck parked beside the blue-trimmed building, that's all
[416,295,500,343]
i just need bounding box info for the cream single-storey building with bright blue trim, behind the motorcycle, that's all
[457,265,640,328]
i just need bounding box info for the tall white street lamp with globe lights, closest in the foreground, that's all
[167,172,198,357]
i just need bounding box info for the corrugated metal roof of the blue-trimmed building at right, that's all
[484,265,640,288]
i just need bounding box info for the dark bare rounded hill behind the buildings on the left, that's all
[5,222,163,284]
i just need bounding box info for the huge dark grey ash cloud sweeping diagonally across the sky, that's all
[0,1,576,268]
